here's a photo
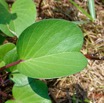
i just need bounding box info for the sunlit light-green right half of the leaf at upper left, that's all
[12,0,36,36]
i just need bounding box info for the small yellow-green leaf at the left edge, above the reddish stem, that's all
[0,43,15,59]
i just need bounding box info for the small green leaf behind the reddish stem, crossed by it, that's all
[3,48,18,72]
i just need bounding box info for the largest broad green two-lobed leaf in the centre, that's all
[17,19,87,78]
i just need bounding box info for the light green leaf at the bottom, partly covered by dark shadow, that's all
[6,73,51,103]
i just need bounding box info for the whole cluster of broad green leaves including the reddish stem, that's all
[0,0,87,103]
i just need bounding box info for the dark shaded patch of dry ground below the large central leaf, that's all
[49,80,89,103]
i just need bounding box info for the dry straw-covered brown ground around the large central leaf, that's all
[35,0,104,103]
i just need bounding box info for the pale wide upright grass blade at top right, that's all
[88,0,96,20]
